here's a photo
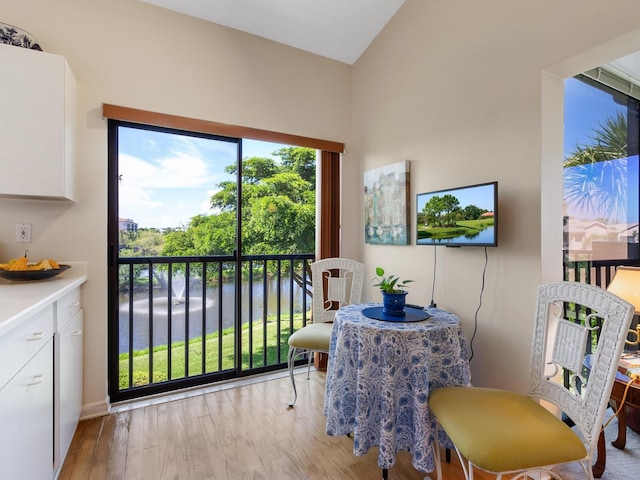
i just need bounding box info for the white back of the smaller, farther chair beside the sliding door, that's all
[311,258,364,323]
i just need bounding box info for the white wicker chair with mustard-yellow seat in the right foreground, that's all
[429,282,634,479]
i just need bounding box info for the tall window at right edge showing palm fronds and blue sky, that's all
[563,75,640,264]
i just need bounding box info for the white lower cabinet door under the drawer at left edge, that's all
[0,339,53,479]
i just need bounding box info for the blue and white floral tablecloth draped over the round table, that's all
[324,303,471,472]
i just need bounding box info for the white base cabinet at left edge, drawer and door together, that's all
[0,306,54,479]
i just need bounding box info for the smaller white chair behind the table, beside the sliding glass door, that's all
[288,258,364,407]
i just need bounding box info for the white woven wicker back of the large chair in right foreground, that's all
[529,282,634,460]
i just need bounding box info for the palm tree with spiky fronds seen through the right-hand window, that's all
[564,113,628,223]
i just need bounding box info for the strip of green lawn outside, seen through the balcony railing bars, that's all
[119,314,309,390]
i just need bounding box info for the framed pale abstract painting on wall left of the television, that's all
[364,160,411,245]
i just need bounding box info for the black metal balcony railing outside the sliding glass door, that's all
[109,254,315,401]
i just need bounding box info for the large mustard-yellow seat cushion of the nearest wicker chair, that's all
[429,387,587,472]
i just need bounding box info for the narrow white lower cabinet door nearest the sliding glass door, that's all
[54,288,83,472]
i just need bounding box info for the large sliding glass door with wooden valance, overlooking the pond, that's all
[104,105,342,401]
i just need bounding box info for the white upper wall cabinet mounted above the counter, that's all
[0,44,76,200]
